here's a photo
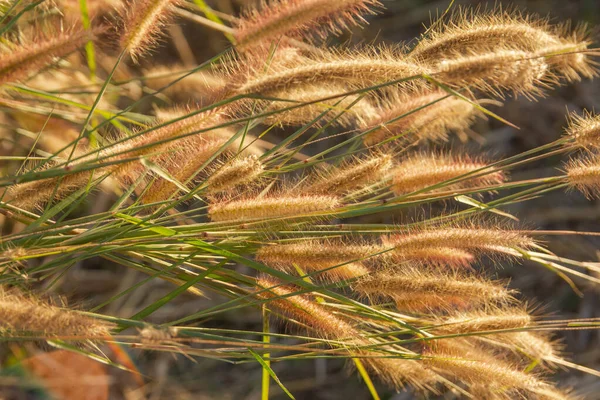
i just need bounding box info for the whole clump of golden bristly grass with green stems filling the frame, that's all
[0,0,600,399]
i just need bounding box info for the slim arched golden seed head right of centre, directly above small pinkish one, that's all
[382,224,535,260]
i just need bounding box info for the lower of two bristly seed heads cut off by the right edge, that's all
[564,154,600,198]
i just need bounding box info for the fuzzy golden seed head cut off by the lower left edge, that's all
[0,288,112,339]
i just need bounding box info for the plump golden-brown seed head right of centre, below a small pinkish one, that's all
[353,267,512,311]
